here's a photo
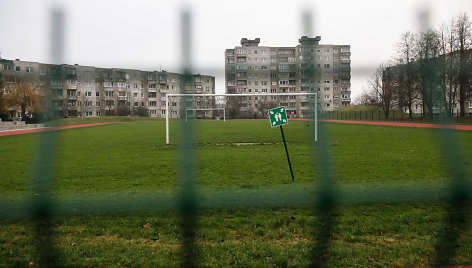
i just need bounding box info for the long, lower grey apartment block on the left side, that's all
[0,59,215,118]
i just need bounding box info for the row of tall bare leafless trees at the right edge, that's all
[357,13,472,120]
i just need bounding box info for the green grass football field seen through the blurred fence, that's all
[0,118,472,267]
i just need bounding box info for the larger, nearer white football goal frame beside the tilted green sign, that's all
[166,92,318,144]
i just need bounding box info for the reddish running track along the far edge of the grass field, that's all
[0,118,472,137]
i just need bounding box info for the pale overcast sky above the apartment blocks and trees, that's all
[0,0,472,99]
